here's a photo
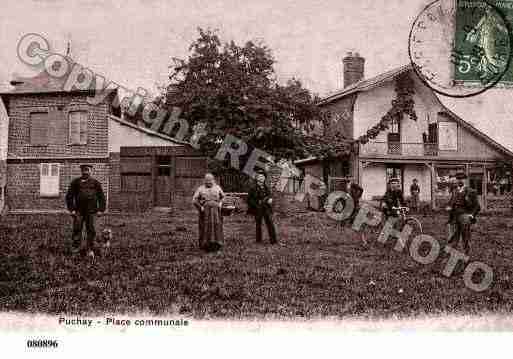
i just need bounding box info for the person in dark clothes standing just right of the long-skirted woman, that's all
[248,173,278,244]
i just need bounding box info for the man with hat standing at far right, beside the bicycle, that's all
[447,172,481,255]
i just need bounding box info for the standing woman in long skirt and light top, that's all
[192,173,224,252]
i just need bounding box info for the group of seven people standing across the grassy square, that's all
[66,164,481,257]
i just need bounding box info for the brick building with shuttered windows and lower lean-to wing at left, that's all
[0,72,206,212]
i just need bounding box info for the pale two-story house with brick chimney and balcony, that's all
[304,53,513,208]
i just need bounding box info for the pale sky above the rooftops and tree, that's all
[0,0,513,149]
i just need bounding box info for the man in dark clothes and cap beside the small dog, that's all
[66,164,105,257]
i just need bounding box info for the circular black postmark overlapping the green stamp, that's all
[408,0,513,97]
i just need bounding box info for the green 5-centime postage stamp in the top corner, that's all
[453,0,513,86]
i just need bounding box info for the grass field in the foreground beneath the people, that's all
[0,212,513,319]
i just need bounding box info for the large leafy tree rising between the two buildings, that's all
[162,29,351,163]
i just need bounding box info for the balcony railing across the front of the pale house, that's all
[360,142,438,156]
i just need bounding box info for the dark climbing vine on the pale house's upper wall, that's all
[357,73,417,144]
